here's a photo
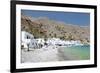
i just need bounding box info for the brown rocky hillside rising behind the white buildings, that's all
[21,15,90,43]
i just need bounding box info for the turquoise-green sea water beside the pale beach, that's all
[64,45,90,60]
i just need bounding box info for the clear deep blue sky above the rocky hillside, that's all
[21,10,90,26]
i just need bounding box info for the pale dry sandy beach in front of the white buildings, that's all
[21,46,59,63]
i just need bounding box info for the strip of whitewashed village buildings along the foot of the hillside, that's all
[21,31,82,49]
